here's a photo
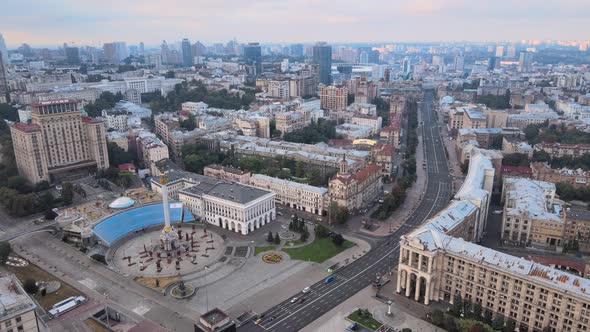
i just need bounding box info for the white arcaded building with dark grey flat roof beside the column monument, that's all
[151,171,276,235]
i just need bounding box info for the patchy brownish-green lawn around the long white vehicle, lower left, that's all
[4,262,82,310]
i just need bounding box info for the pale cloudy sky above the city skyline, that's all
[0,0,590,47]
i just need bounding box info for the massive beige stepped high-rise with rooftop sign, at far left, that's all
[10,99,109,183]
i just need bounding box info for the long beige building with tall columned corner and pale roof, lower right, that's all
[396,148,590,331]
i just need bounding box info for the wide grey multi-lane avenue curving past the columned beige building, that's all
[239,90,452,331]
